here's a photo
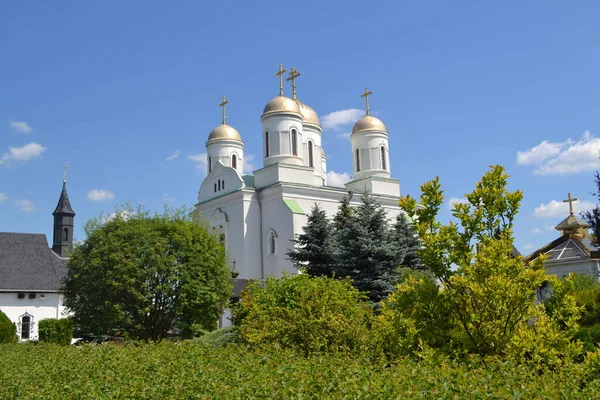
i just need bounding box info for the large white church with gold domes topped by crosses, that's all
[196,65,401,284]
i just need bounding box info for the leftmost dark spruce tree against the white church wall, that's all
[287,204,335,277]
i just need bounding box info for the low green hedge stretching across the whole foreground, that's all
[0,342,600,400]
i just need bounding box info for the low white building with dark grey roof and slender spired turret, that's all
[0,176,75,341]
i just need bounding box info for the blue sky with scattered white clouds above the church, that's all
[0,1,600,253]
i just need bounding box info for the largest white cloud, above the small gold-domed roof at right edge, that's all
[517,131,600,175]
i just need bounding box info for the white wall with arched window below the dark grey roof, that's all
[0,291,67,340]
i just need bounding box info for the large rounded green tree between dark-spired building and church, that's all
[64,207,229,340]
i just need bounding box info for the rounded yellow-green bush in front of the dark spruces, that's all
[237,275,373,355]
